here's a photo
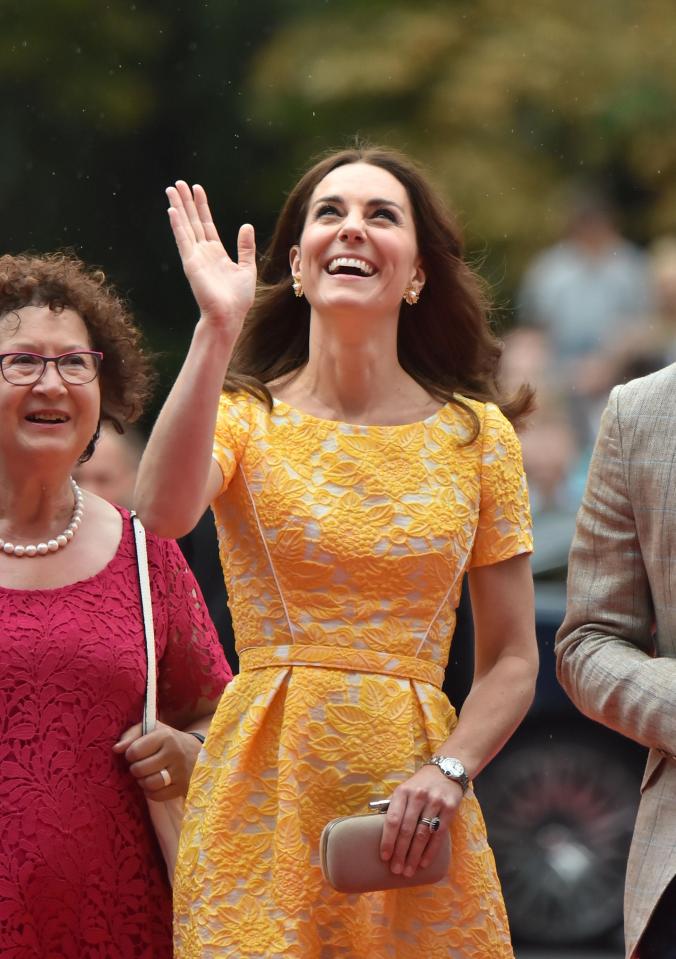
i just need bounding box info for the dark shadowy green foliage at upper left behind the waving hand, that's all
[0,0,282,414]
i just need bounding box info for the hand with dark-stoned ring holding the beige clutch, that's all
[380,765,463,876]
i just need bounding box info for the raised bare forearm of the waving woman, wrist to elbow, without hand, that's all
[134,320,234,538]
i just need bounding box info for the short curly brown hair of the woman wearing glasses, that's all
[0,252,155,462]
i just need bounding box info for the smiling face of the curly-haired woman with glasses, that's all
[0,306,100,465]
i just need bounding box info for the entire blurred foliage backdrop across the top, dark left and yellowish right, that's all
[0,0,676,392]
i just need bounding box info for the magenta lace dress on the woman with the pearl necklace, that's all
[0,511,230,959]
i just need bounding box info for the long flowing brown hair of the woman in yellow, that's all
[223,145,533,439]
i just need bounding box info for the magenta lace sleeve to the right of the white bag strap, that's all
[148,535,232,712]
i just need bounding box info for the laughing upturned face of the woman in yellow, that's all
[290,163,425,316]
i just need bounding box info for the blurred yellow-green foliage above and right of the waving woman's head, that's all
[250,0,676,286]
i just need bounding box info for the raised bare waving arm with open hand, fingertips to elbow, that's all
[134,180,256,537]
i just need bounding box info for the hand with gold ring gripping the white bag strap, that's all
[113,723,200,802]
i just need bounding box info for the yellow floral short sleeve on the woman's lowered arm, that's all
[470,403,533,567]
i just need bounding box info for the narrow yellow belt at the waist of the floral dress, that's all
[239,645,445,689]
